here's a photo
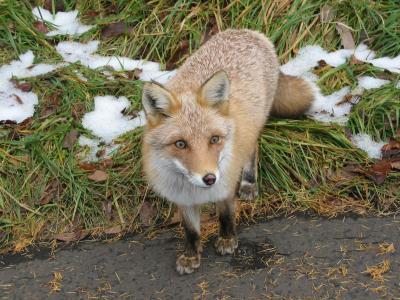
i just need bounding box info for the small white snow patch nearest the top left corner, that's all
[32,6,93,36]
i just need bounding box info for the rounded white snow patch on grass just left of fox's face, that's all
[82,96,146,143]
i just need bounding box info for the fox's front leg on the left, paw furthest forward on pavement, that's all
[176,206,201,275]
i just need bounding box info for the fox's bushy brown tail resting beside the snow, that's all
[271,72,314,118]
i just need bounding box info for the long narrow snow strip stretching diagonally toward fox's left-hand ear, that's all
[56,41,175,83]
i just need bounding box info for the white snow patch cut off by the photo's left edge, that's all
[0,51,58,123]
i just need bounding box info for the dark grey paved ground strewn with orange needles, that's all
[0,216,400,300]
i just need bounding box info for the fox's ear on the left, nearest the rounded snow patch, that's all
[142,82,175,117]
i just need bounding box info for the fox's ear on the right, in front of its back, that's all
[201,71,230,106]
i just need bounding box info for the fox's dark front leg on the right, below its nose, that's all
[215,197,238,255]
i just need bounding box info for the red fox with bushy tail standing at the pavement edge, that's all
[142,30,314,274]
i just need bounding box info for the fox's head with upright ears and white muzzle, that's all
[142,71,233,188]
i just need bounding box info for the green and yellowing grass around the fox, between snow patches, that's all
[0,0,400,250]
